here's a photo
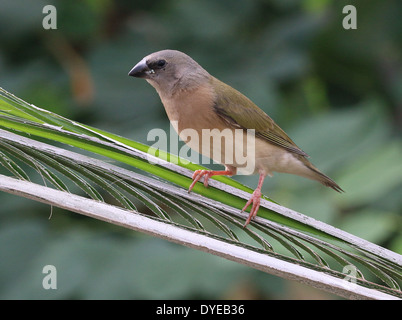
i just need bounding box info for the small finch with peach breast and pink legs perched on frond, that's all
[128,49,344,227]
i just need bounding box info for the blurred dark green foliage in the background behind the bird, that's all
[0,0,402,299]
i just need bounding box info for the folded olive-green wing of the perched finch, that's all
[211,78,308,157]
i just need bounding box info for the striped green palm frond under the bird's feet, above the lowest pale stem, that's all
[0,88,402,297]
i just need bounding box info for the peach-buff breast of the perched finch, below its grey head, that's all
[161,86,251,173]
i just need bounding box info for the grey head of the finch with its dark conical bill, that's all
[128,50,210,96]
